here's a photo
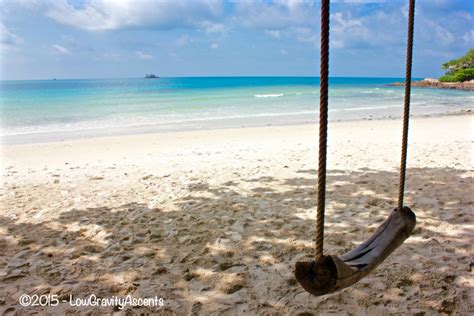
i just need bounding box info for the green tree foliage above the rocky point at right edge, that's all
[439,48,474,82]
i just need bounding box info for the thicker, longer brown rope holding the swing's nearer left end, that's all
[316,0,329,261]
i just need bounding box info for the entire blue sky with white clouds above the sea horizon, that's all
[0,0,474,80]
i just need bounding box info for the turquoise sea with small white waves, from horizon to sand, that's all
[0,77,474,144]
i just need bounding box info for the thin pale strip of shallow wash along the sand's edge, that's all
[0,109,472,146]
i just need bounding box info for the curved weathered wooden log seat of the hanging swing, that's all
[295,206,416,296]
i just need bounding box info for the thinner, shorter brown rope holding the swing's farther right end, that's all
[398,0,415,214]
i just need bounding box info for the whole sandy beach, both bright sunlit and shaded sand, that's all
[0,115,474,315]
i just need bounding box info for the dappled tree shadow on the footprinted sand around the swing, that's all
[0,168,474,315]
